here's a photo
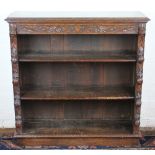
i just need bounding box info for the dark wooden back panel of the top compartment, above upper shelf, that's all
[18,35,137,54]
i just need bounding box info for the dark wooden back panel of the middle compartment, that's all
[20,63,134,89]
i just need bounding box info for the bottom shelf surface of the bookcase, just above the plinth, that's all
[23,120,132,137]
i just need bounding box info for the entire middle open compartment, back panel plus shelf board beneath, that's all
[19,62,135,100]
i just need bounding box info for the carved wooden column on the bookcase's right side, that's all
[133,23,145,134]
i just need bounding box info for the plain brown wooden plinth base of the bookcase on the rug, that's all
[15,135,139,148]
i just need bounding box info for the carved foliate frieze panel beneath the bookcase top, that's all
[17,24,138,34]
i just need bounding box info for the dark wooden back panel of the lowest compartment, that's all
[22,100,133,120]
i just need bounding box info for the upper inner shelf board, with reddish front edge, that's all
[19,51,136,62]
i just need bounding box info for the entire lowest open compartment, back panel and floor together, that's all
[22,100,133,135]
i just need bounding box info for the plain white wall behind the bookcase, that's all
[0,0,155,128]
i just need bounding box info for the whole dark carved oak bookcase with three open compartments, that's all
[6,12,149,147]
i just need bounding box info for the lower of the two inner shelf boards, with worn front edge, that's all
[21,87,134,100]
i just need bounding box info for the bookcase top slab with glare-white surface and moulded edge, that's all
[6,11,149,22]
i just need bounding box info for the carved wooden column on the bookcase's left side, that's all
[10,24,22,134]
